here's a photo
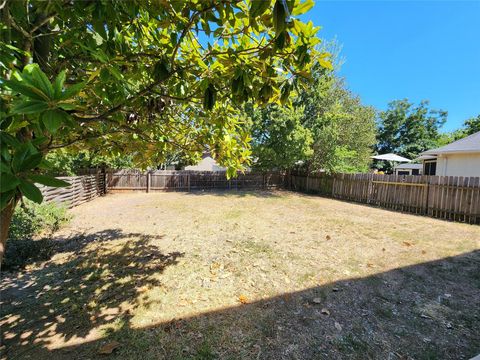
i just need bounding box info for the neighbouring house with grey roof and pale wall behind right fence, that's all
[418,131,480,176]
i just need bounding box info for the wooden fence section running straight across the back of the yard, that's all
[107,170,284,192]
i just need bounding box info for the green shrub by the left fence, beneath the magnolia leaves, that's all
[2,201,70,268]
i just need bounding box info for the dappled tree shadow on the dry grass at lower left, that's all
[0,229,183,359]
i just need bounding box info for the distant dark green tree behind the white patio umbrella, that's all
[375,99,447,163]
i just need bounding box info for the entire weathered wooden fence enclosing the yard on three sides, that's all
[41,170,480,224]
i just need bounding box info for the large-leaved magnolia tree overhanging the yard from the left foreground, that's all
[0,0,331,262]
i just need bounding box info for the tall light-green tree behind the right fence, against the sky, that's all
[299,74,375,173]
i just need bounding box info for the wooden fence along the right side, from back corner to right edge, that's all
[288,174,480,224]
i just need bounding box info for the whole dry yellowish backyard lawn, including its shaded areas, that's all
[1,192,480,359]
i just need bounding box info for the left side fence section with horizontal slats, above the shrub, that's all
[39,170,106,208]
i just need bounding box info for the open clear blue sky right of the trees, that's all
[302,0,480,131]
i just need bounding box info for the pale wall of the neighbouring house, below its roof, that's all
[436,153,480,176]
